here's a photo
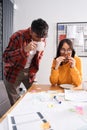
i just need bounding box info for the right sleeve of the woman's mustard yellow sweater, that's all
[70,57,82,86]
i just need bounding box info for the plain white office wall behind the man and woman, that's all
[14,0,87,84]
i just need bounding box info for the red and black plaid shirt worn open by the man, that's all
[3,28,45,83]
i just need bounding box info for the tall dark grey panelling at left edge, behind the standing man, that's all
[0,0,14,80]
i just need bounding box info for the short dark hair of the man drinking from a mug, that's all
[31,18,49,38]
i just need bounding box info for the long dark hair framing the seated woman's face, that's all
[55,39,75,58]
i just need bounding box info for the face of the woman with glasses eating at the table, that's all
[60,42,72,62]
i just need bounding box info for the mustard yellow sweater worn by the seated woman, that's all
[50,56,82,86]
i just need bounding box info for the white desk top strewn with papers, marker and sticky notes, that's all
[0,86,87,130]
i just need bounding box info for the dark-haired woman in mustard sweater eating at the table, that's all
[50,39,82,86]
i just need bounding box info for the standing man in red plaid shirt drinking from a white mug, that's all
[3,19,49,105]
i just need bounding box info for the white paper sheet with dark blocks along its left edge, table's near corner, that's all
[8,112,43,130]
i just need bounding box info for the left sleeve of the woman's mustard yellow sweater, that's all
[50,60,59,85]
